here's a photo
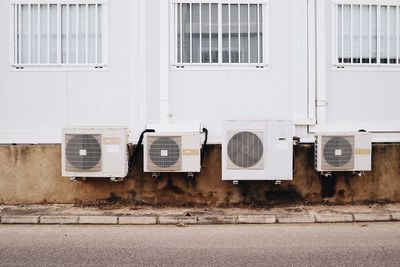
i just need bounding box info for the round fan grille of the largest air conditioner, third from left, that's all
[227,131,264,169]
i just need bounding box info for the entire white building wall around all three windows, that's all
[0,0,400,143]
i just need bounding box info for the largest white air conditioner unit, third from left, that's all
[222,121,293,181]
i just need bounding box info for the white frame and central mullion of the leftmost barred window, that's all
[9,0,108,71]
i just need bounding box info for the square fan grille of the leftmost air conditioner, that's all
[65,134,101,172]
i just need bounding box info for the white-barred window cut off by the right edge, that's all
[334,1,400,66]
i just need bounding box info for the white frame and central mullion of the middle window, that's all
[169,0,270,70]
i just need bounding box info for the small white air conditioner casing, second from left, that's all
[143,132,202,173]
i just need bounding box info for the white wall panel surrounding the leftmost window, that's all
[0,0,140,143]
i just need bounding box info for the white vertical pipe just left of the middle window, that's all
[158,0,171,124]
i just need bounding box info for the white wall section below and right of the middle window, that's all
[164,0,308,143]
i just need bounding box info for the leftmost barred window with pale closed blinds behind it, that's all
[12,1,105,69]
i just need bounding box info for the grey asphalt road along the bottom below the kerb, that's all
[0,223,400,266]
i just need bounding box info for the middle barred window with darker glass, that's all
[173,1,266,66]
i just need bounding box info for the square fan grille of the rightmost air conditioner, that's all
[321,136,354,170]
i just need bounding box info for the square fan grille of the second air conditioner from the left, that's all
[147,136,182,171]
